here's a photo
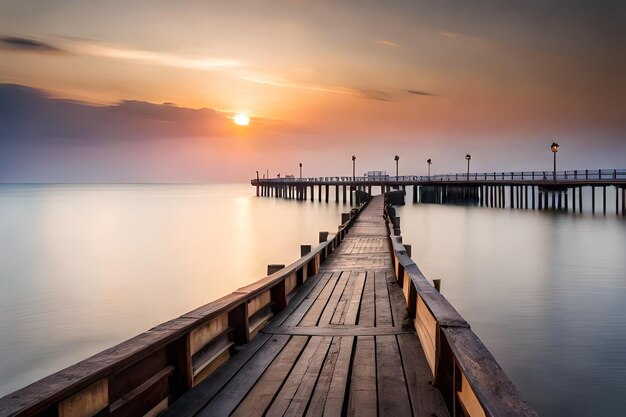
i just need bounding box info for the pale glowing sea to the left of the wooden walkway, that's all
[0,184,349,396]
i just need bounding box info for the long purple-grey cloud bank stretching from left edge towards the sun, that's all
[0,84,231,146]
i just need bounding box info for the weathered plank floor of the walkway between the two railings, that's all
[164,196,448,417]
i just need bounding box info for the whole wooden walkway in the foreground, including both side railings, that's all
[0,196,536,417]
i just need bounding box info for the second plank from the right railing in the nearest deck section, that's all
[376,336,411,417]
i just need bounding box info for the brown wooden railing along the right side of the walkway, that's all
[385,198,537,417]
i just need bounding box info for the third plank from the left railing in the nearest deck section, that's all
[232,336,308,417]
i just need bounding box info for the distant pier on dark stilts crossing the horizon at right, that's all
[251,169,626,216]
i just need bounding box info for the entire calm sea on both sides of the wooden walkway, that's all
[0,185,626,416]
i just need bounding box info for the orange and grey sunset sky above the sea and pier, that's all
[0,0,626,182]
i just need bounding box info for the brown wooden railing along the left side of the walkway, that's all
[0,200,365,417]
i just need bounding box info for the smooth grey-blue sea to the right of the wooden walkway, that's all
[397,188,626,417]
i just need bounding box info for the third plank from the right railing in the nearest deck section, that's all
[348,336,378,417]
